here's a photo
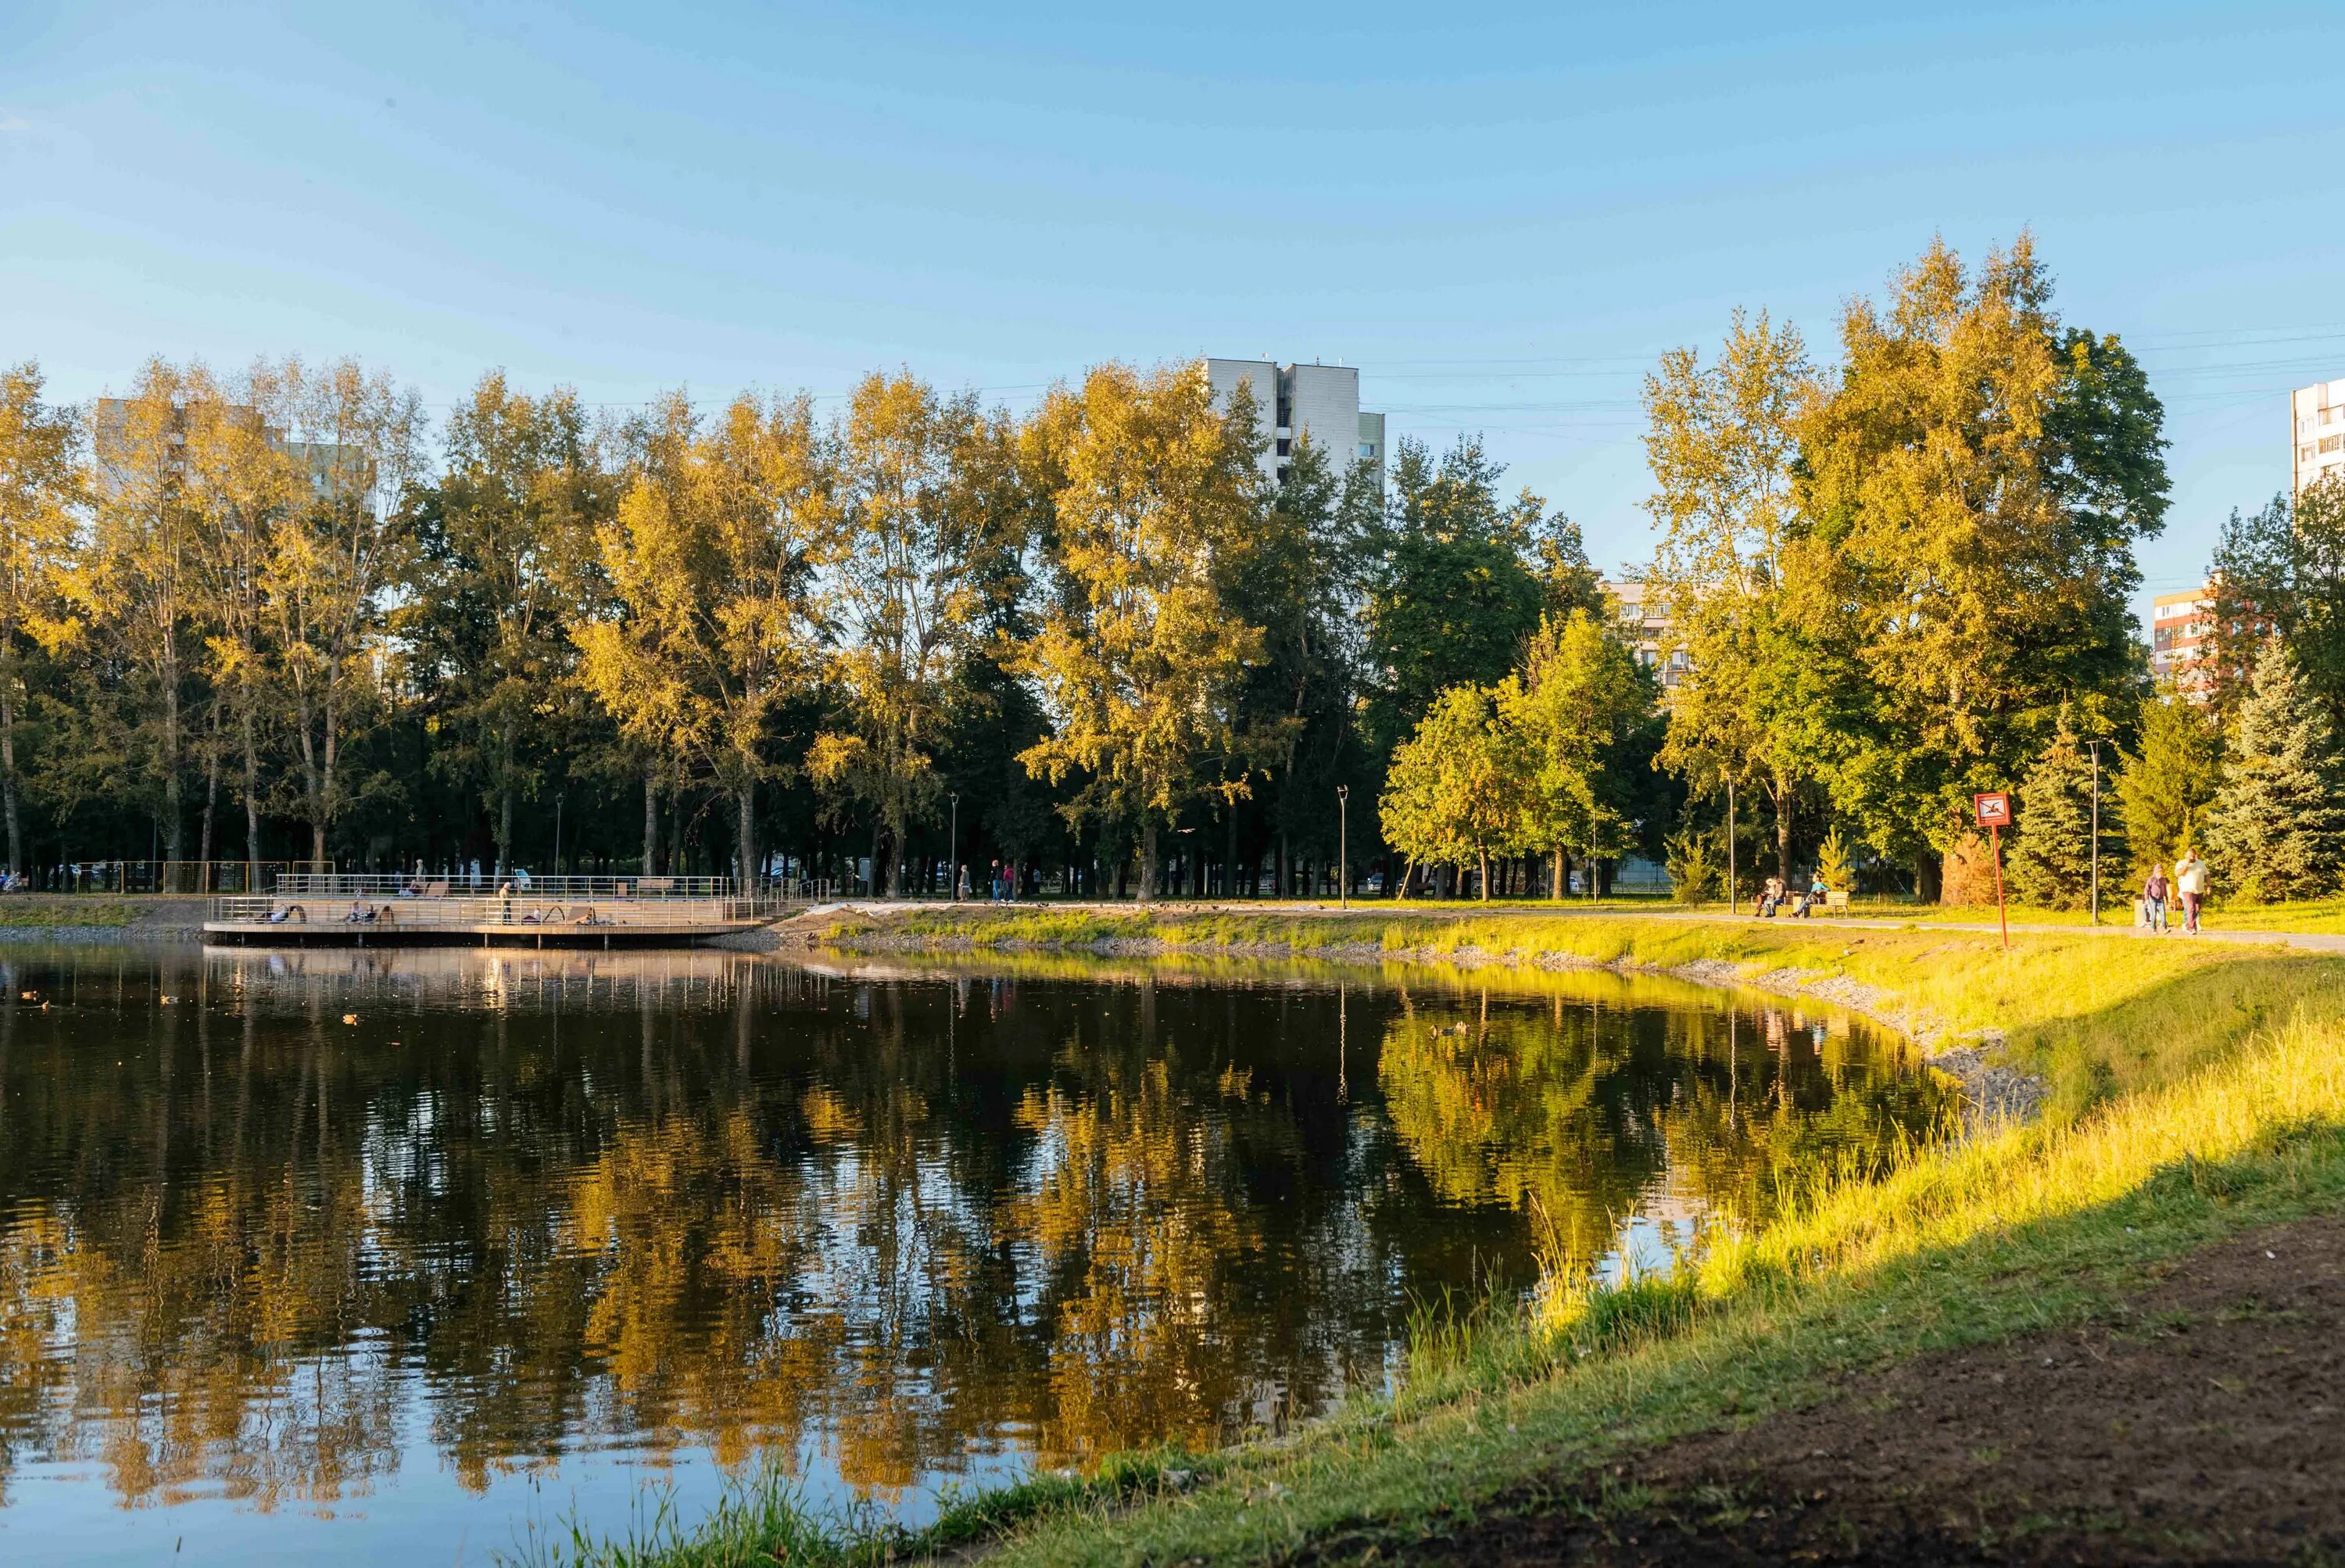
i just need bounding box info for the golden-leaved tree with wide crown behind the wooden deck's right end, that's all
[575,392,840,886]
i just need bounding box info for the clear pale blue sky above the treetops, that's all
[0,0,2345,618]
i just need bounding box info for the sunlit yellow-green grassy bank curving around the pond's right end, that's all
[523,911,2345,1563]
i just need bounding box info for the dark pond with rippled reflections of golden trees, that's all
[0,947,1949,1563]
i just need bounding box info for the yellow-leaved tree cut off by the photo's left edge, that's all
[0,361,87,874]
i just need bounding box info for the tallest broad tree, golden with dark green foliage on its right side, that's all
[1799,234,2167,890]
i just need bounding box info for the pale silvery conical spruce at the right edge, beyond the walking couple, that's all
[2207,638,2345,902]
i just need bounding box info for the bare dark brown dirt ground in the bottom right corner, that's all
[1384,1219,2345,1566]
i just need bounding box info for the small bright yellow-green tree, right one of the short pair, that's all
[1498,610,1653,900]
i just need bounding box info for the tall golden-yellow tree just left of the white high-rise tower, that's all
[1018,363,1278,900]
